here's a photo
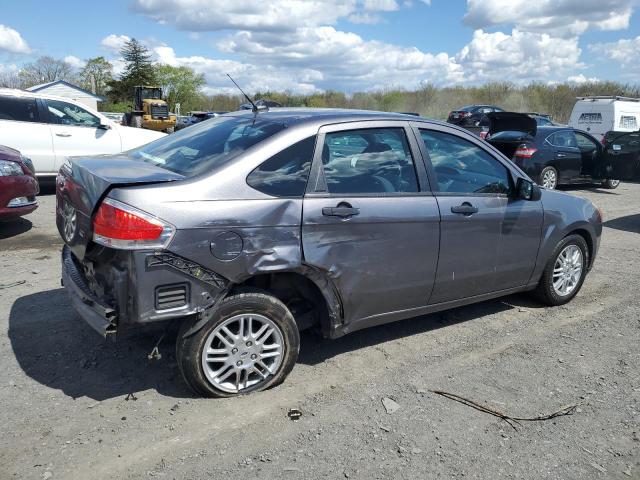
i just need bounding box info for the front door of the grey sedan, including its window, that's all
[416,125,542,304]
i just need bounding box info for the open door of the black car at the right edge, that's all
[594,131,640,180]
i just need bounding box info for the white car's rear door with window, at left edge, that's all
[0,95,55,175]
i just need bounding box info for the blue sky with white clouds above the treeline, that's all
[0,0,640,94]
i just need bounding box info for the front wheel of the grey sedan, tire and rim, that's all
[535,235,589,306]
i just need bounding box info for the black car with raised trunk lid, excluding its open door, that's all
[486,112,620,189]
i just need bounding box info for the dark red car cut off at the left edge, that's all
[0,145,40,220]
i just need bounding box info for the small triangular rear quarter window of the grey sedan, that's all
[247,136,316,197]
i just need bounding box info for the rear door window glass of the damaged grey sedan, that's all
[322,128,418,194]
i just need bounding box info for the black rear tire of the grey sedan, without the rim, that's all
[176,292,300,398]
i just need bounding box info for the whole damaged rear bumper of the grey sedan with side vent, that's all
[62,245,228,337]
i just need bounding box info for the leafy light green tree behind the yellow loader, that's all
[155,65,205,112]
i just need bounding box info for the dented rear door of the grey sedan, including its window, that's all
[302,121,440,330]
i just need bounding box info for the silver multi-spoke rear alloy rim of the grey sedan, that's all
[202,314,284,393]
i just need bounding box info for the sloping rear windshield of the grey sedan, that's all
[130,116,285,177]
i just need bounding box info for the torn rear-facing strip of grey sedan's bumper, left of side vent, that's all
[62,246,118,337]
